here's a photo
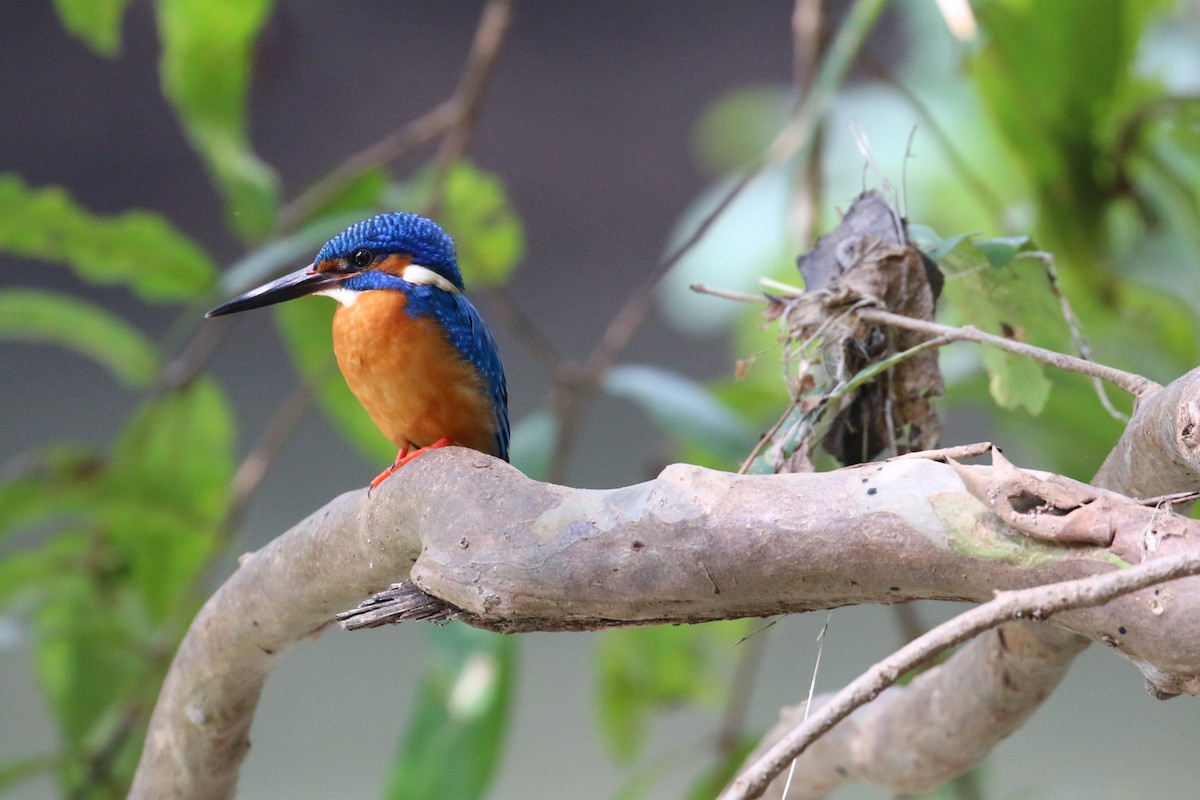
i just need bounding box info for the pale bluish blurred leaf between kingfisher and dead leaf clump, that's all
[605,365,756,458]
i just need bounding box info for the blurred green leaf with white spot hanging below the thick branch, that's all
[386,622,517,800]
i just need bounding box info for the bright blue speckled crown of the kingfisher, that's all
[316,212,463,290]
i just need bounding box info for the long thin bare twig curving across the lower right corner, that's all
[721,552,1200,800]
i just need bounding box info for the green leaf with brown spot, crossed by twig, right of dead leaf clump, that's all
[940,239,1072,415]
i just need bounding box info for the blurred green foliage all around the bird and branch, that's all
[0,0,1200,798]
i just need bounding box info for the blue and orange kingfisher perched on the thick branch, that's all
[205,213,509,489]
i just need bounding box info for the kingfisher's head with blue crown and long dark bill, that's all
[205,212,463,317]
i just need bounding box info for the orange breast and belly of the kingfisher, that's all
[334,289,496,455]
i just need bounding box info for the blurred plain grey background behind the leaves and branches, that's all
[0,0,1200,800]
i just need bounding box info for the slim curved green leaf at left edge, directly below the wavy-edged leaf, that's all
[0,289,161,389]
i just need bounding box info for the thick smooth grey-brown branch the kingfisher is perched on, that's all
[131,447,1200,798]
